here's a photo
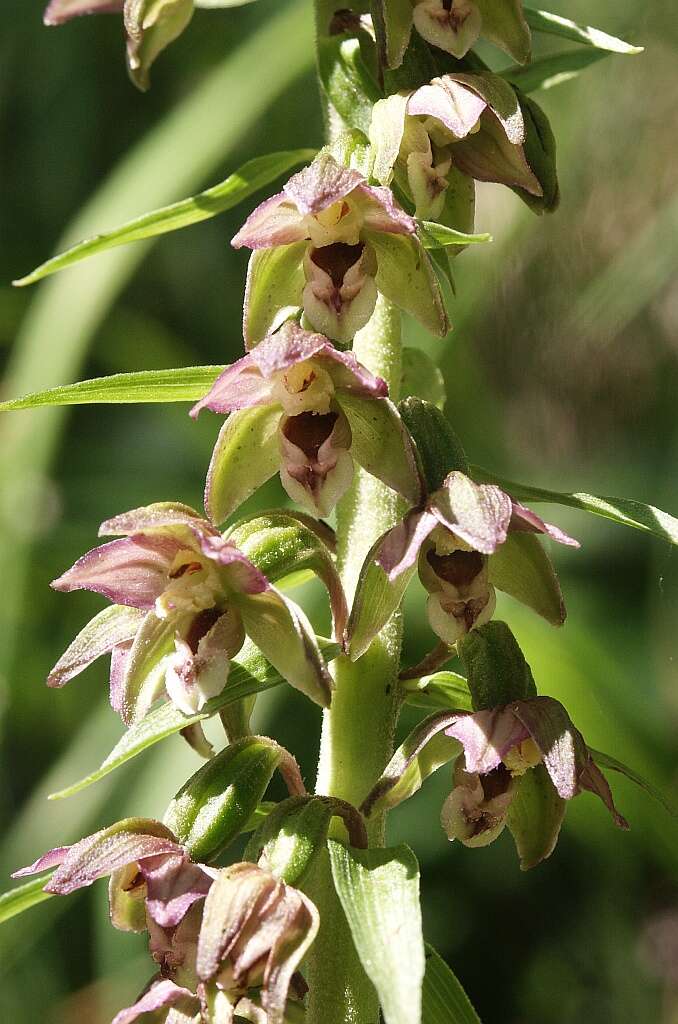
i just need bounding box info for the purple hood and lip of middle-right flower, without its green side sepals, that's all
[374,471,579,644]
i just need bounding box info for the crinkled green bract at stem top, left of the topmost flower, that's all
[317,35,383,133]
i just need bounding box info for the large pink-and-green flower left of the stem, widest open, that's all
[47,502,331,723]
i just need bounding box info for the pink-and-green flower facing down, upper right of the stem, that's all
[370,72,544,224]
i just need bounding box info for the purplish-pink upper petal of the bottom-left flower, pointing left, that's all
[45,818,183,896]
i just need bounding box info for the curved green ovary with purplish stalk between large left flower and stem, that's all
[228,511,348,638]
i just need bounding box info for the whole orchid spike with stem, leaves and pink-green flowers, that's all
[2,6,678,1024]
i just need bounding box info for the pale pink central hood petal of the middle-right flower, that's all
[429,471,511,555]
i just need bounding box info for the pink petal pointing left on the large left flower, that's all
[51,535,185,609]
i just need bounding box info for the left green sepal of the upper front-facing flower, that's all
[243,242,306,349]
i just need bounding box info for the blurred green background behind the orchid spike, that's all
[0,0,678,1024]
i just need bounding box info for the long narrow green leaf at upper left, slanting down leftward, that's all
[13,150,316,288]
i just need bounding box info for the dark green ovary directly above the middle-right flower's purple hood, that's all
[398,397,469,494]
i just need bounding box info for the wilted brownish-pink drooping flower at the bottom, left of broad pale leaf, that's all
[197,863,319,1024]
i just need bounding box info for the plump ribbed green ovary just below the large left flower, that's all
[163,736,282,861]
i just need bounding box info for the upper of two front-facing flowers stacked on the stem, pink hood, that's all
[232,151,449,348]
